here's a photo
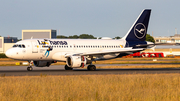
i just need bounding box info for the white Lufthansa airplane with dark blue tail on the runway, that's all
[5,9,155,71]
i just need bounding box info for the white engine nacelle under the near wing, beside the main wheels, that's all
[66,56,87,68]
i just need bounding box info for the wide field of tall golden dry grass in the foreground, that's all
[0,74,180,101]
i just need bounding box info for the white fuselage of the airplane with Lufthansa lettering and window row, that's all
[6,39,126,61]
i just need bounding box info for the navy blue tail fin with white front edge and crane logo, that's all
[123,9,151,42]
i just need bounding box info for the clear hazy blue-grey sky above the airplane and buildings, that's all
[0,0,180,39]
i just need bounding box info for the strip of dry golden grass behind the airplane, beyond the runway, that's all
[0,58,180,66]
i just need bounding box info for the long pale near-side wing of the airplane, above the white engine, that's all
[65,47,144,57]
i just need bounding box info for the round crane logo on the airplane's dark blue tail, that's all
[134,23,146,39]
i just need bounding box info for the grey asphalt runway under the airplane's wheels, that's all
[0,64,180,76]
